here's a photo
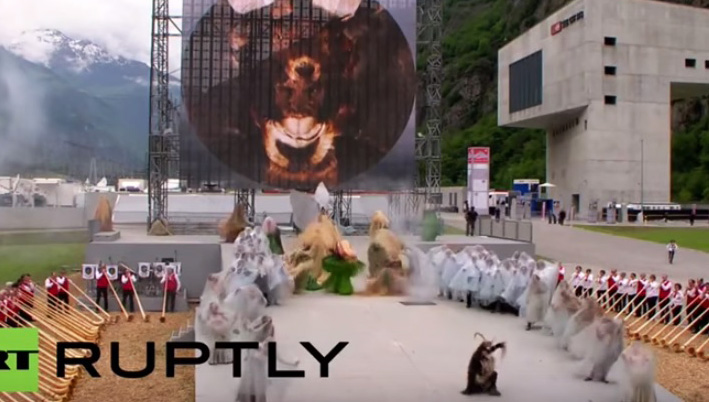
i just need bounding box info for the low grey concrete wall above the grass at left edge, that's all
[0,207,86,230]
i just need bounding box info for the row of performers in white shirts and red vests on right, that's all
[560,266,709,333]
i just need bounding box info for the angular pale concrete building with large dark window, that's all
[498,0,709,214]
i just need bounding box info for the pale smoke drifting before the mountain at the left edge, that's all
[0,48,48,175]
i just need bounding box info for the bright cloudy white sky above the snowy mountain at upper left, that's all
[0,0,183,70]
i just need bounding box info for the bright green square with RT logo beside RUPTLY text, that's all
[0,328,39,392]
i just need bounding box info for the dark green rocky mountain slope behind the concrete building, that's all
[442,0,709,202]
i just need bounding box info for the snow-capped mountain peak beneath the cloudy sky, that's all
[8,29,150,87]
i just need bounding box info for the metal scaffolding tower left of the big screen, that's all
[147,0,181,230]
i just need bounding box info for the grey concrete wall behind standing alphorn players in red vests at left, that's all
[85,242,222,298]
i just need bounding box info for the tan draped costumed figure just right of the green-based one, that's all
[366,212,410,295]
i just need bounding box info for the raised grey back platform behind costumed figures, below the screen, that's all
[85,225,535,299]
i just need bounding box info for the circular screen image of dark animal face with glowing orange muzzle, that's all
[182,0,416,189]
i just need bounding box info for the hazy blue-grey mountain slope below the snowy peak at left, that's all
[0,44,147,177]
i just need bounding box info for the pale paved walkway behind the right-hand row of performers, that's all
[444,214,709,283]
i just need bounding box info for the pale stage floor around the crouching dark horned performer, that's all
[195,293,681,402]
